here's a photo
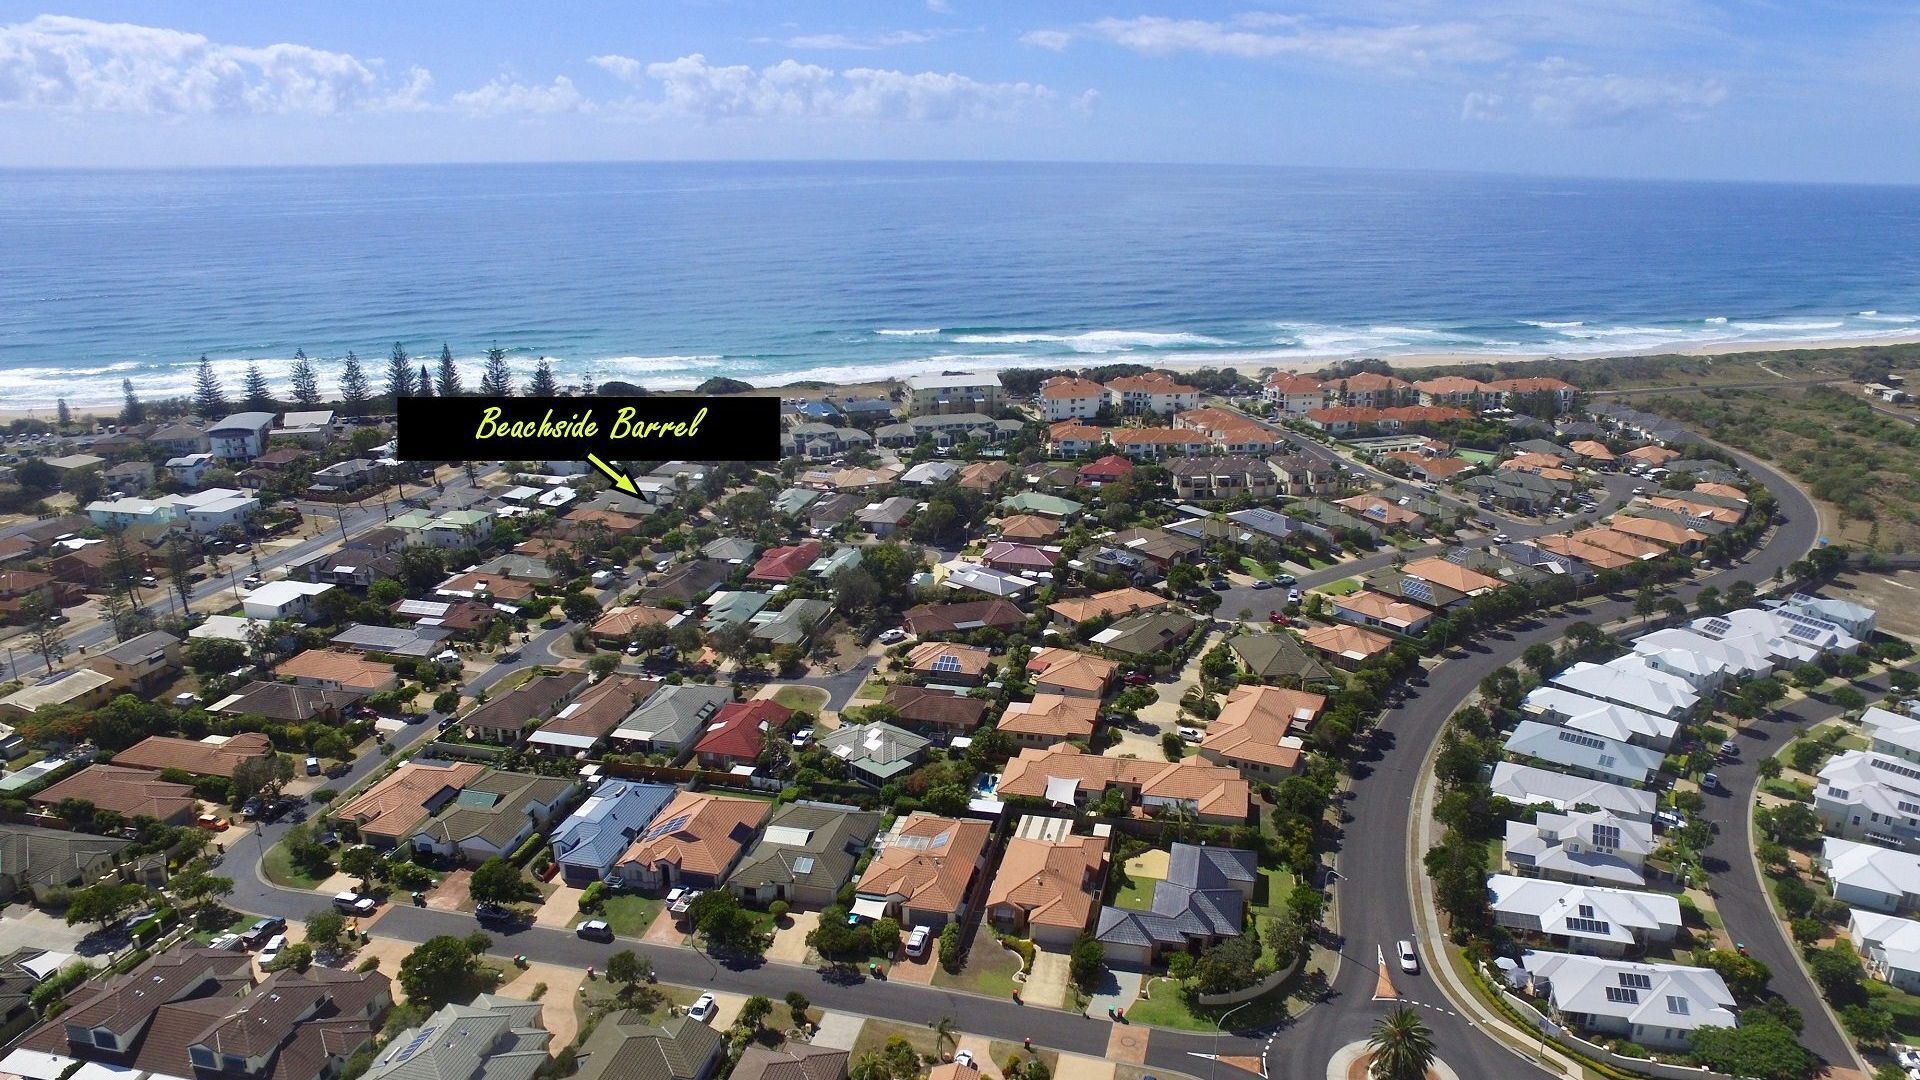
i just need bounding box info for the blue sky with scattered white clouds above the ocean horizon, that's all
[0,0,1920,183]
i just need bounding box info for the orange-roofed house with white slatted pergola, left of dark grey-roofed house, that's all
[987,817,1106,949]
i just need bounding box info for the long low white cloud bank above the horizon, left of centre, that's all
[595,54,1056,121]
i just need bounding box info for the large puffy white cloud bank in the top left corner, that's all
[0,15,432,115]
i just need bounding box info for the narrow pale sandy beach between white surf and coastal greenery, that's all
[0,331,1920,423]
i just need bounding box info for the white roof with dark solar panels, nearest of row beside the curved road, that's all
[1521,951,1734,1030]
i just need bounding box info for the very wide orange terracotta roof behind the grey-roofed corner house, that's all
[998,744,1252,824]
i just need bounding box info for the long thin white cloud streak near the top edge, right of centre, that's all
[1059,12,1511,71]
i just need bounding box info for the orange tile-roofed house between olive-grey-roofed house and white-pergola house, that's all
[852,811,993,930]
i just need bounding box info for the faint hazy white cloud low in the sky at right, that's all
[1461,56,1728,127]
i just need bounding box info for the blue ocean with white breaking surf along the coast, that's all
[0,163,1920,407]
